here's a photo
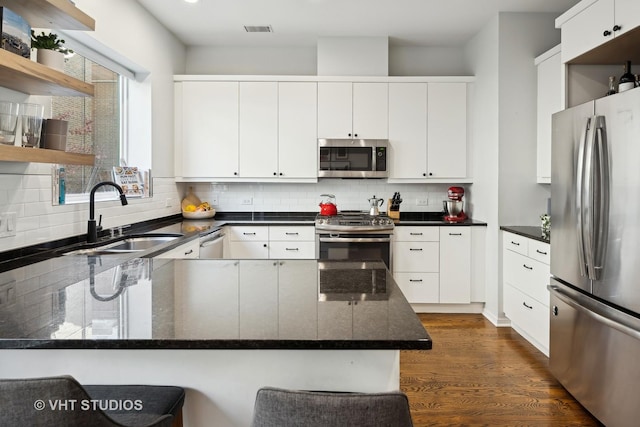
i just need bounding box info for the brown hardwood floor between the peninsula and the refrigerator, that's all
[400,314,601,427]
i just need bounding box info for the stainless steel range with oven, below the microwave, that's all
[315,212,394,270]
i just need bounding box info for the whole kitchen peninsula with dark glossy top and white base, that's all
[0,257,432,426]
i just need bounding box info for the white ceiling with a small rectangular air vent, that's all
[137,0,579,47]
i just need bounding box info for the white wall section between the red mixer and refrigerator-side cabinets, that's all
[466,13,560,325]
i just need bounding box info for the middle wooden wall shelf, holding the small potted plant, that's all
[0,49,94,96]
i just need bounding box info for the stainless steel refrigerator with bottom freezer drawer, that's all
[549,89,640,426]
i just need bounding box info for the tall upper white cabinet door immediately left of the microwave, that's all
[278,82,318,178]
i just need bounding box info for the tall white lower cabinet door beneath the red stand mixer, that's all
[440,227,471,304]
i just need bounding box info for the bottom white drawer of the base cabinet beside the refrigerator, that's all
[504,285,549,349]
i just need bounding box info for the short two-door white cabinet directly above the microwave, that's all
[318,82,389,139]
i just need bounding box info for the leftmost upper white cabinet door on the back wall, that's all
[180,82,238,178]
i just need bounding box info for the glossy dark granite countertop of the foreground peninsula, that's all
[0,256,432,350]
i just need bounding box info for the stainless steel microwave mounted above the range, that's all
[318,139,389,178]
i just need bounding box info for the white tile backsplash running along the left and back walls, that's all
[0,169,469,252]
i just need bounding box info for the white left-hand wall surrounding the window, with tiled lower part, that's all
[0,0,185,251]
